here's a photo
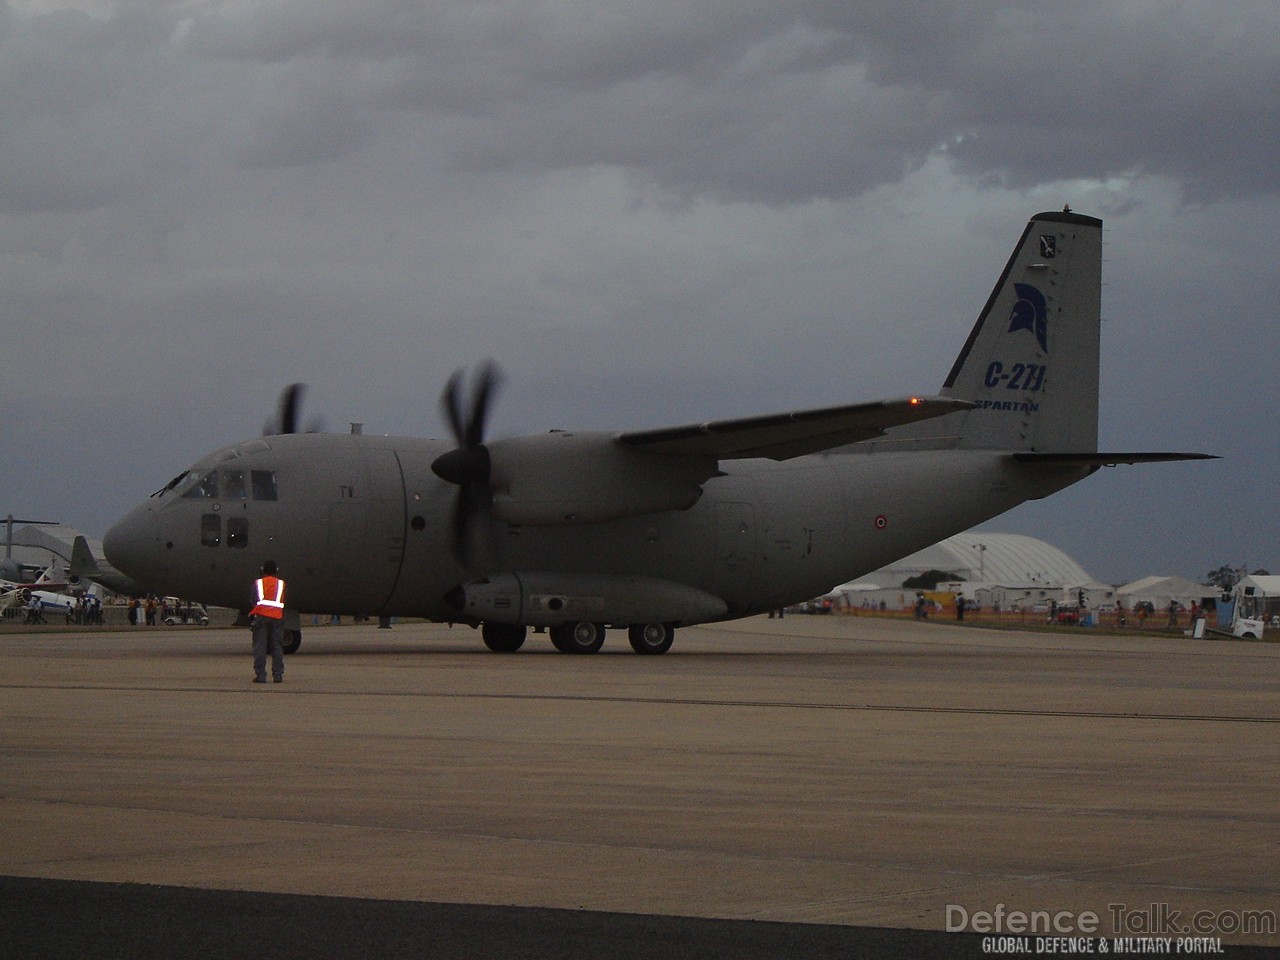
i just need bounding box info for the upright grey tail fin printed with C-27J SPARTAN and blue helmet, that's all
[941,211,1102,453]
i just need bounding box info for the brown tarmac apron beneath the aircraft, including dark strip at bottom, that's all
[0,617,1280,957]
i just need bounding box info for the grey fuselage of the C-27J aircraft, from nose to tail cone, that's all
[106,434,1089,620]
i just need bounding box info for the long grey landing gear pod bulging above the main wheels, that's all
[448,572,728,627]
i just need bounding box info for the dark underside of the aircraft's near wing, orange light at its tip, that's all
[617,397,975,460]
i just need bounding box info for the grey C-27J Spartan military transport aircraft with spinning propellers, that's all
[104,211,1206,654]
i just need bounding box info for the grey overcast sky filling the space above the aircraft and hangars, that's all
[0,0,1280,581]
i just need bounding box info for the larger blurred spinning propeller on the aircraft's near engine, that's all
[431,360,502,566]
